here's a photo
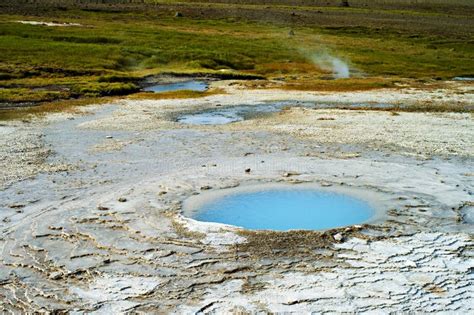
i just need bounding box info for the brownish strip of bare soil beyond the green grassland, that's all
[4,0,474,40]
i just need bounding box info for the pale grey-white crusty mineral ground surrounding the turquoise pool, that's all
[0,83,474,314]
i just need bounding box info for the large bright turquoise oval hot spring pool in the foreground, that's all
[193,189,375,231]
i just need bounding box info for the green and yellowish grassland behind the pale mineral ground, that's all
[0,0,474,106]
